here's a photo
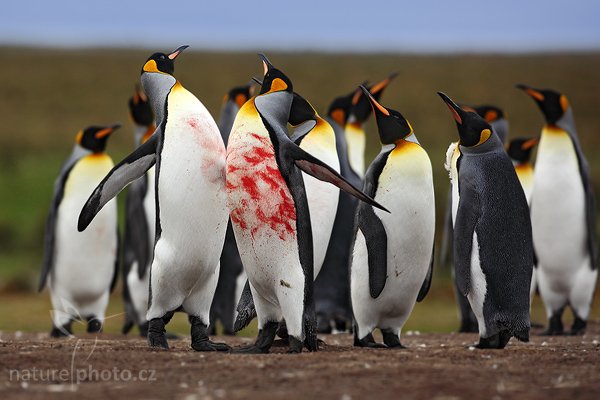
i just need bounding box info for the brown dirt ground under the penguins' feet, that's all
[0,322,600,400]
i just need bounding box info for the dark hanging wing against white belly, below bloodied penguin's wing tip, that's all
[358,203,387,299]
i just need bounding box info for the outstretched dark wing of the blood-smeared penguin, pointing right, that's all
[286,141,389,212]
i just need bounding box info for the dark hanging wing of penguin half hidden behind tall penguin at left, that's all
[123,174,151,279]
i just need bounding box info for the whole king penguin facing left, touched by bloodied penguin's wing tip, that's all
[350,86,435,348]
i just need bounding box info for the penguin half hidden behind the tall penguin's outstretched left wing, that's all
[122,87,156,337]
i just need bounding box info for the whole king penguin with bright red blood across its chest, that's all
[227,55,381,353]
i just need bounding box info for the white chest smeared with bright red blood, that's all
[227,108,301,292]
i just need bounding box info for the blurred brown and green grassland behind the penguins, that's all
[0,47,600,333]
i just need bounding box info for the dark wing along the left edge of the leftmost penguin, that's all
[38,162,76,292]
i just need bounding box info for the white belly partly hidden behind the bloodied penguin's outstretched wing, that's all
[300,130,340,277]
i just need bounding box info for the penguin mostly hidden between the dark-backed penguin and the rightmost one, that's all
[506,137,539,299]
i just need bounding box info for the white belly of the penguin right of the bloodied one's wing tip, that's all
[351,144,435,336]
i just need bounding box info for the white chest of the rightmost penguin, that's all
[531,127,586,270]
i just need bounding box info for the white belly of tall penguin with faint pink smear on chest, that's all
[152,88,227,291]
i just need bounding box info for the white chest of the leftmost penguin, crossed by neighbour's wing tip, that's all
[55,154,117,300]
